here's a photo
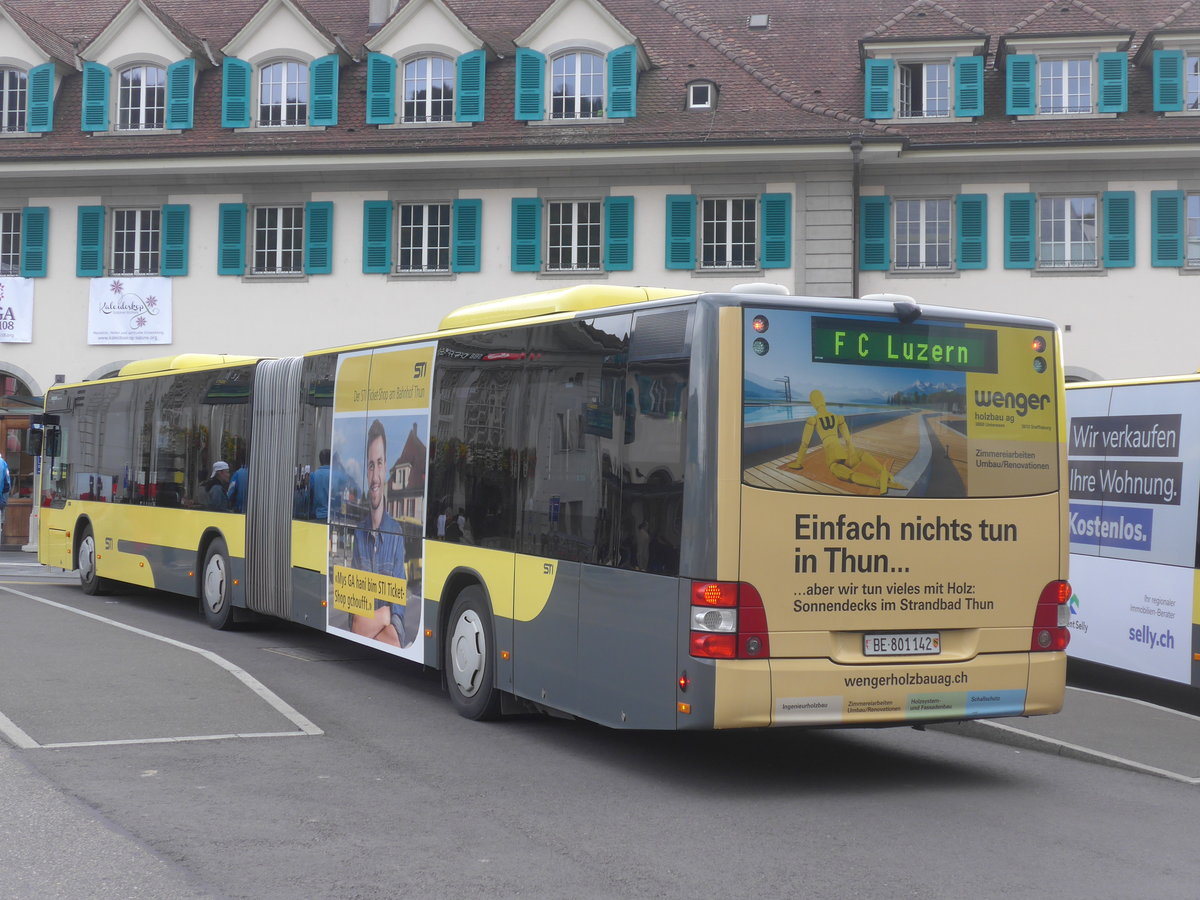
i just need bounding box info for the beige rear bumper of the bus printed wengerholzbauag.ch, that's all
[713,653,1067,728]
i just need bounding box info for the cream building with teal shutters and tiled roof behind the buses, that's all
[0,0,1200,409]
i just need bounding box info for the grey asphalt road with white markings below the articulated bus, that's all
[0,568,1200,900]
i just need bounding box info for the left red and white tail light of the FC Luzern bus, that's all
[690,581,770,659]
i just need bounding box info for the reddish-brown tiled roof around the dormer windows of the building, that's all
[0,0,1200,164]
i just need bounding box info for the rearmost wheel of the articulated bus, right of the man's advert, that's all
[445,584,500,720]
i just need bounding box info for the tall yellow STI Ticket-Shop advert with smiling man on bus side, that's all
[328,343,434,662]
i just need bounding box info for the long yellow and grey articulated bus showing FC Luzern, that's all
[38,286,1070,730]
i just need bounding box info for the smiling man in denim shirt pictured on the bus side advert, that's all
[350,419,421,647]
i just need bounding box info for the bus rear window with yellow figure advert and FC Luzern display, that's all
[742,307,1060,498]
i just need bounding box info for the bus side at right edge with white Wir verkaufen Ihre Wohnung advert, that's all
[1067,374,1200,686]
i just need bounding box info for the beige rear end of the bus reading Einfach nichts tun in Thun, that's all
[689,298,1069,727]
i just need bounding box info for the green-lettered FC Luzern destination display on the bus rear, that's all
[812,317,996,373]
